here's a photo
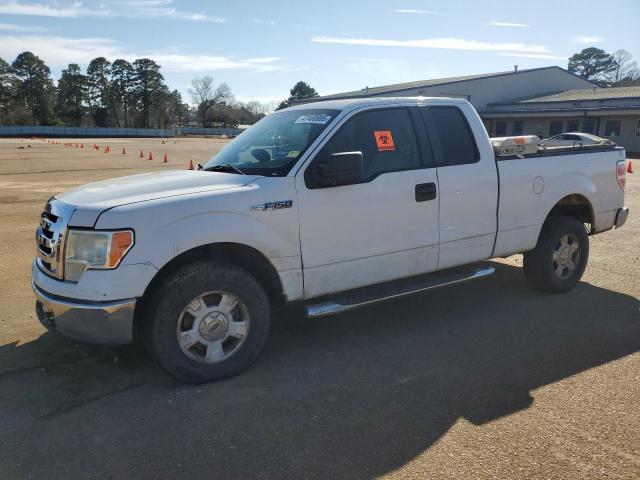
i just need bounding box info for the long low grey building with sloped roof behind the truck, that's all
[310,66,640,152]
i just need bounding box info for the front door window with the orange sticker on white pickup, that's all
[311,108,422,181]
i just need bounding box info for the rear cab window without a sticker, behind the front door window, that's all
[420,107,480,167]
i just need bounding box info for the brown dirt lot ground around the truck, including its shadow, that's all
[0,139,640,479]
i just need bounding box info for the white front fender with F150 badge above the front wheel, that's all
[96,184,301,296]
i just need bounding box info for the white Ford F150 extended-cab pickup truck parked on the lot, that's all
[33,98,628,383]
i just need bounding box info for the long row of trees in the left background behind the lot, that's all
[0,52,268,128]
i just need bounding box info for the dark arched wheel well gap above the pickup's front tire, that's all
[134,243,285,333]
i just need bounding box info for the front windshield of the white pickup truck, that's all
[204,109,340,177]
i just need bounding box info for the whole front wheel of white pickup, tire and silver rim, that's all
[146,262,271,384]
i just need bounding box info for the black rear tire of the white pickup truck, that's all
[524,215,589,293]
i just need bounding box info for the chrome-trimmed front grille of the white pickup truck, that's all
[36,198,75,279]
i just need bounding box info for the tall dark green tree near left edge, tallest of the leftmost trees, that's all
[11,52,54,125]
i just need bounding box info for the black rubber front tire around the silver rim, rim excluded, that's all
[144,261,271,384]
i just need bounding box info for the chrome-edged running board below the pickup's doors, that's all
[306,265,496,318]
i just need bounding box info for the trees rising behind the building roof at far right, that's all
[568,47,640,87]
